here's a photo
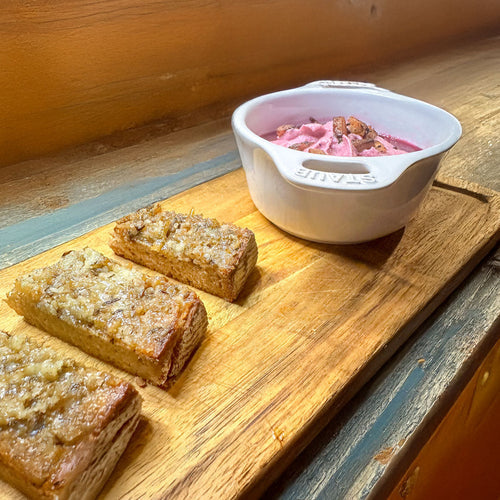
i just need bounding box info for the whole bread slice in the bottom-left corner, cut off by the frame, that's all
[0,332,141,500]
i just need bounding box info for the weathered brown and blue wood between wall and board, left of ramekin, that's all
[0,120,241,268]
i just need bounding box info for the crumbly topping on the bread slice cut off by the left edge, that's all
[0,332,135,484]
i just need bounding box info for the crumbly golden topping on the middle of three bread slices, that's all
[11,248,196,355]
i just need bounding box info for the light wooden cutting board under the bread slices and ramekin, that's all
[0,170,500,499]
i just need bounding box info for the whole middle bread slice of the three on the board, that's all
[7,248,207,386]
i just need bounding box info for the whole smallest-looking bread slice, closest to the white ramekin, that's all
[110,204,257,301]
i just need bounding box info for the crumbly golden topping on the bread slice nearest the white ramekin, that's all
[115,204,247,269]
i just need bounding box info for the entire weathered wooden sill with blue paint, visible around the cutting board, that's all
[0,36,500,498]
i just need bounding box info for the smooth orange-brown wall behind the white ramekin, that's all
[0,0,500,166]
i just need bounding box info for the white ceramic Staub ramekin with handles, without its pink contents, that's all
[232,81,462,243]
